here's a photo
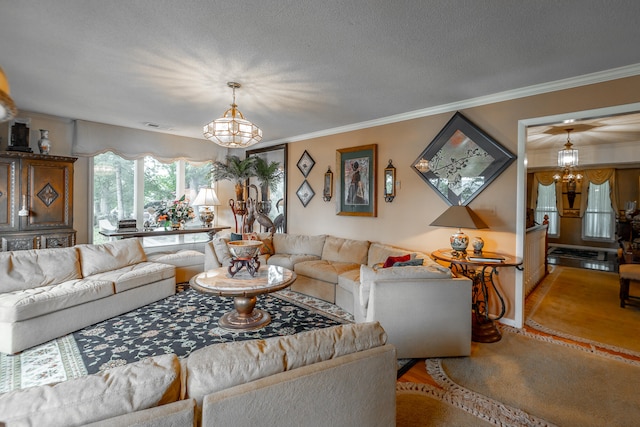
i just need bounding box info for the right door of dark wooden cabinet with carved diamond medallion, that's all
[22,160,73,230]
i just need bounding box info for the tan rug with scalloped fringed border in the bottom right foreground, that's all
[436,327,640,427]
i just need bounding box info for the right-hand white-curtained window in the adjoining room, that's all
[582,181,615,241]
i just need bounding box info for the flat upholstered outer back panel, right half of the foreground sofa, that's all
[202,345,397,427]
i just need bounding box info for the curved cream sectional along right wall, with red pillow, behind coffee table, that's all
[205,233,472,358]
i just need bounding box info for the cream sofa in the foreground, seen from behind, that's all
[0,323,396,427]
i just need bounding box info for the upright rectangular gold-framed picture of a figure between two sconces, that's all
[336,144,378,216]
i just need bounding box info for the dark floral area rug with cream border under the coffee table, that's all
[0,288,353,393]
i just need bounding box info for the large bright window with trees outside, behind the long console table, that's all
[93,152,210,243]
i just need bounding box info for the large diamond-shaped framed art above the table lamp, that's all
[411,112,516,206]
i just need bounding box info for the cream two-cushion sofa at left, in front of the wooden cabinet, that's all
[0,239,176,354]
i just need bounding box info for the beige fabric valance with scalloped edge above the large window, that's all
[72,120,227,163]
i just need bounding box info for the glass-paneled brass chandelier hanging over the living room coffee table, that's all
[203,82,262,148]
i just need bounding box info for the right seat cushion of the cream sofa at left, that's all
[90,261,176,293]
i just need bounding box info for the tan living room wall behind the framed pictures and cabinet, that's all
[0,76,640,322]
